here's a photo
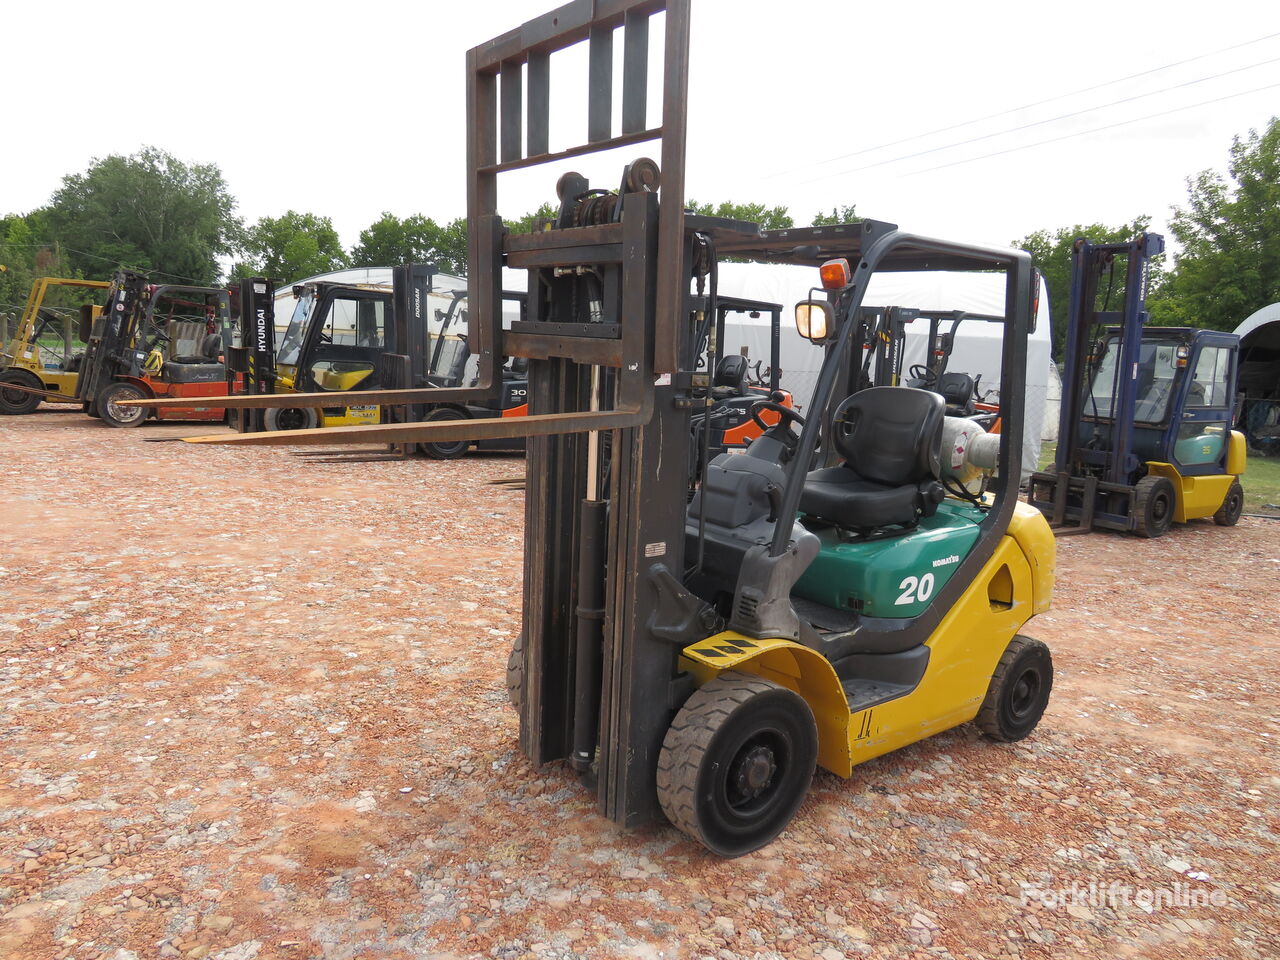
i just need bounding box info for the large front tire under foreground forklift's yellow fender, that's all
[658,671,818,856]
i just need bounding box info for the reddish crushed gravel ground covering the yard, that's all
[0,412,1280,960]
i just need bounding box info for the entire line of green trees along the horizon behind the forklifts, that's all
[0,118,1280,358]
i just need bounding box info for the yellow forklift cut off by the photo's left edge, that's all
[0,276,111,415]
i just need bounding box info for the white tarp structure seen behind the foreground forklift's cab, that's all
[718,264,1061,474]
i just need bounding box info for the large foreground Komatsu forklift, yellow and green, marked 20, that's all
[172,0,1053,855]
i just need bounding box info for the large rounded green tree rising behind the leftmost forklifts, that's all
[46,147,241,284]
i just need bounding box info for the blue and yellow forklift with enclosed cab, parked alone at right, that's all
[1028,233,1245,538]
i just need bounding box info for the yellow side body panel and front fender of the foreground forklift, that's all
[682,503,1056,777]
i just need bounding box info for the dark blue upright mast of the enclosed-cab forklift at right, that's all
[1055,233,1165,484]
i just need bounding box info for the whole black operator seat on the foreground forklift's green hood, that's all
[800,387,946,532]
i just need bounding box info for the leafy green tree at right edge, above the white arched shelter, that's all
[1152,116,1280,330]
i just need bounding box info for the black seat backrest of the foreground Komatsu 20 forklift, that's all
[832,387,946,486]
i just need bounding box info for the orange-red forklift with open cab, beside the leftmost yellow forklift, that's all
[76,270,230,426]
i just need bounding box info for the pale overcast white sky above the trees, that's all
[10,0,1280,256]
